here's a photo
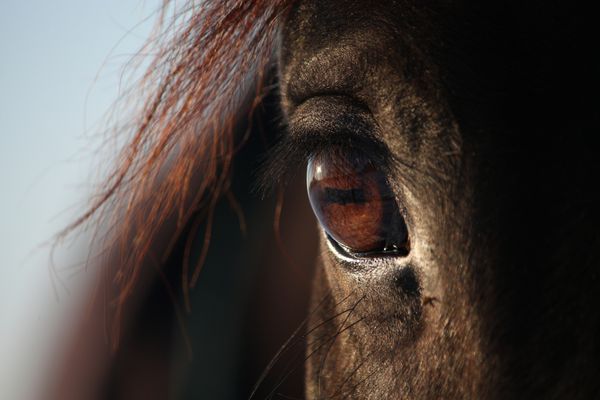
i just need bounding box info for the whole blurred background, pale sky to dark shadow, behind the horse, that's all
[0,0,317,400]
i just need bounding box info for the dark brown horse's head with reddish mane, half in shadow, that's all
[51,0,600,399]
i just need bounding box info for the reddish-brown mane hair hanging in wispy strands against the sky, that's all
[60,0,291,346]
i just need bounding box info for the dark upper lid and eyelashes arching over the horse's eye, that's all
[255,131,396,196]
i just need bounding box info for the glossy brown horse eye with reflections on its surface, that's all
[306,152,409,255]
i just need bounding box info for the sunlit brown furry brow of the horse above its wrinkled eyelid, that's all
[279,5,447,141]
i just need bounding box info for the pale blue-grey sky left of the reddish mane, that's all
[0,0,162,400]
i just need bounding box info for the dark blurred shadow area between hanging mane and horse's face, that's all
[105,86,317,400]
